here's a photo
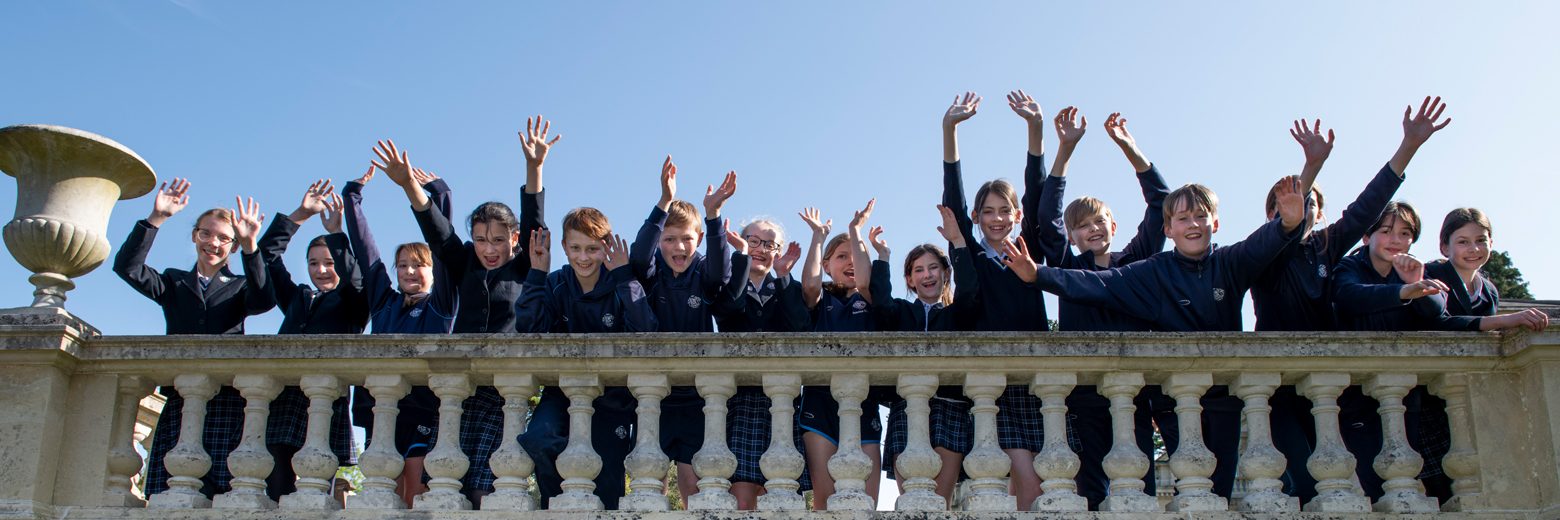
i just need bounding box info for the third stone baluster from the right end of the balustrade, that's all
[1295,372,1370,512]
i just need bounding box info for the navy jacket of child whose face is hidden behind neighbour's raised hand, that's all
[1251,166,1402,331]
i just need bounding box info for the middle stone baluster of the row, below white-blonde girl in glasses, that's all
[758,373,807,511]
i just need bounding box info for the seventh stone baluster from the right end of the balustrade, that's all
[1030,372,1089,511]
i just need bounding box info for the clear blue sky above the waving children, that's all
[0,0,1560,334]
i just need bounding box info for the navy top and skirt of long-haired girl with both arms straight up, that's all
[942,156,1050,453]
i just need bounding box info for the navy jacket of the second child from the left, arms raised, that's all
[259,212,368,334]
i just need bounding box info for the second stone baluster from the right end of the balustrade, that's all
[1362,373,1441,512]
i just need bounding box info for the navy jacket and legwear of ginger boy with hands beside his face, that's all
[515,265,657,509]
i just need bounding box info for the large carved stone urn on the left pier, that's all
[0,125,158,308]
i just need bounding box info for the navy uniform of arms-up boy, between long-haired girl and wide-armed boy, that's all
[1023,155,1178,508]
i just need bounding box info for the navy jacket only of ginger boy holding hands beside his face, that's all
[515,265,657,333]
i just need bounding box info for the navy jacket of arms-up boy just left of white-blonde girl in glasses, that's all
[629,208,747,333]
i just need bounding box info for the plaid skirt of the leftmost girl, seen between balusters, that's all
[147,386,245,497]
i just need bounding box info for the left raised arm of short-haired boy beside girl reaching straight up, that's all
[1023,106,1089,267]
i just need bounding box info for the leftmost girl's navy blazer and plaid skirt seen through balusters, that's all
[114,220,276,498]
